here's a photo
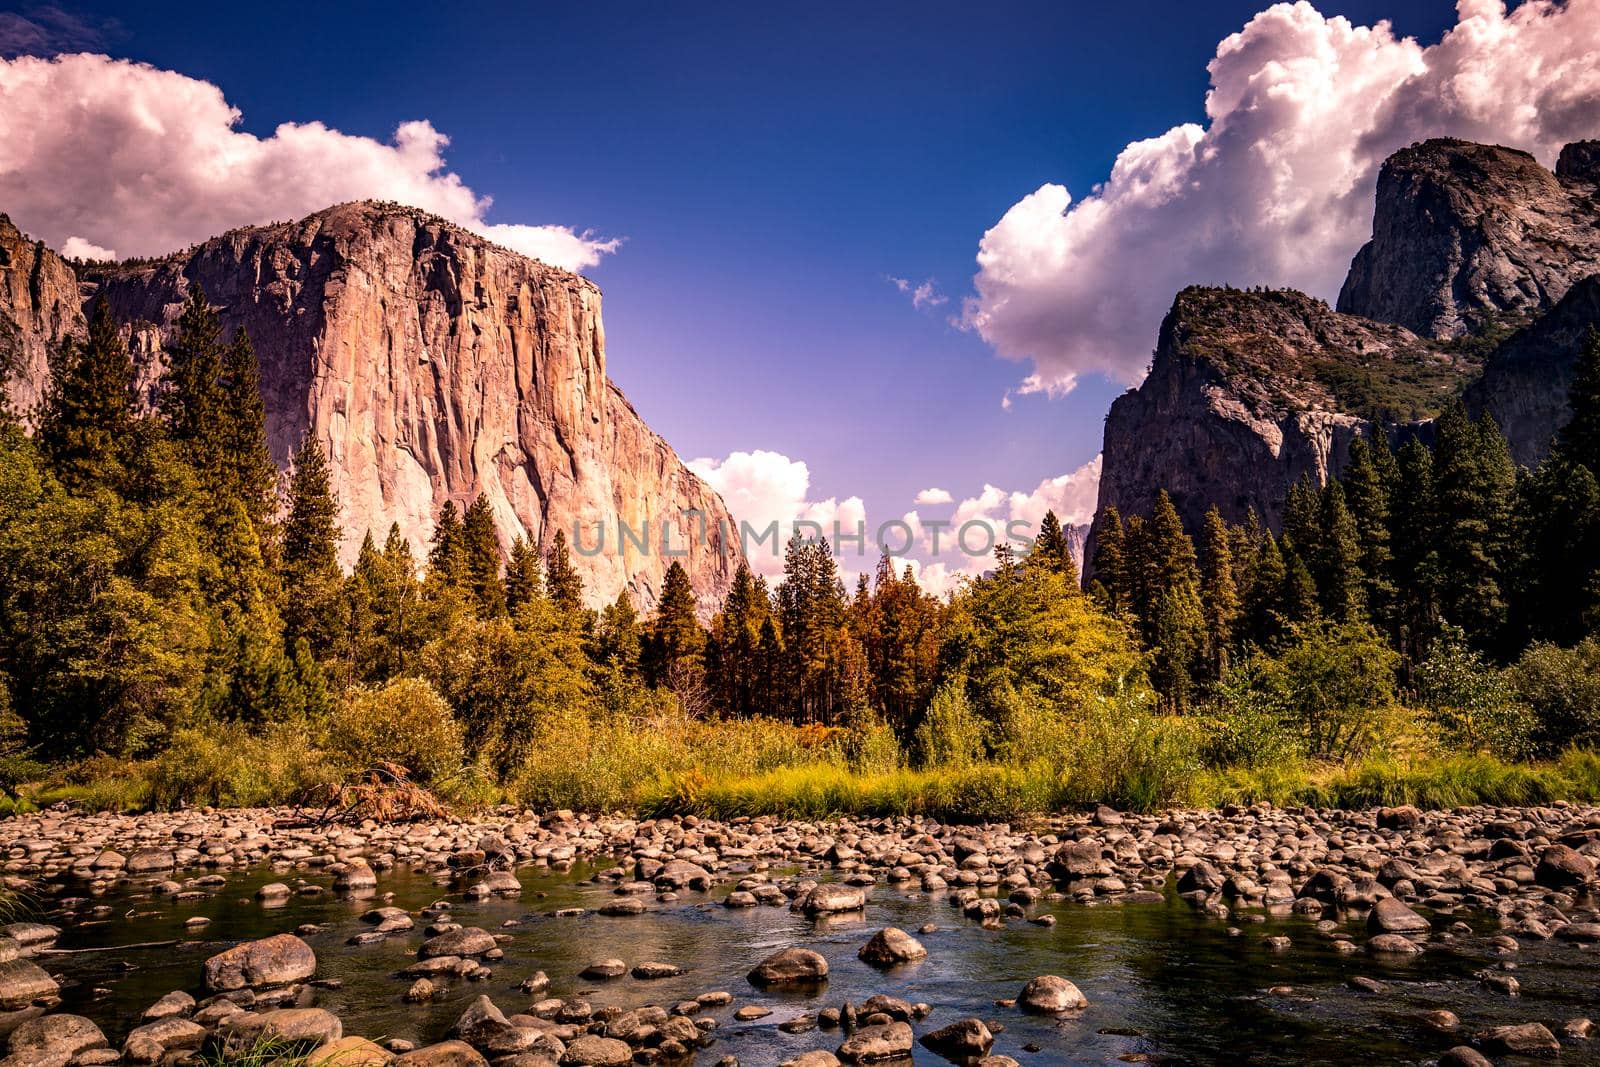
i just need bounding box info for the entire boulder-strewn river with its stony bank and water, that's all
[0,806,1600,1067]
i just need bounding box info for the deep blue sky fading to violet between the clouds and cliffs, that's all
[0,2,1484,579]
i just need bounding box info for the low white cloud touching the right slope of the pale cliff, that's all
[688,450,877,581]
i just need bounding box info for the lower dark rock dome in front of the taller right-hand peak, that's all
[1099,286,1477,530]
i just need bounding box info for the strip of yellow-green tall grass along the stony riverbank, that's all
[21,696,1600,821]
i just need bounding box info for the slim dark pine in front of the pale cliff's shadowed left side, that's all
[283,435,342,656]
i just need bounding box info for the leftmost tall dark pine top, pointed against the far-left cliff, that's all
[35,298,134,488]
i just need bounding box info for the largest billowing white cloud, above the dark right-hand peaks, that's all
[963,0,1600,394]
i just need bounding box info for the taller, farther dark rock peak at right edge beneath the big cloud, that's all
[1339,138,1600,338]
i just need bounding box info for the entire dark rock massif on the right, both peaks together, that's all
[1086,139,1600,566]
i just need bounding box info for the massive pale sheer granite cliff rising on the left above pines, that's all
[5,202,738,608]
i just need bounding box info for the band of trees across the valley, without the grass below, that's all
[9,279,1600,796]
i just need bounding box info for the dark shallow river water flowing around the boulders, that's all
[42,864,1600,1067]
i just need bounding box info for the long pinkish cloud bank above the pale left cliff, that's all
[0,54,619,270]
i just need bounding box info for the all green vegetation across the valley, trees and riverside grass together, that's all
[0,290,1600,819]
